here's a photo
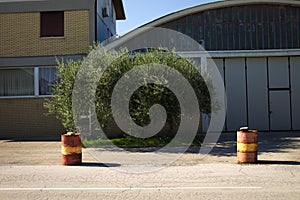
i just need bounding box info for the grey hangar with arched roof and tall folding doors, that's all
[110,0,300,131]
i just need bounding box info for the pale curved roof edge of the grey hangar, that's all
[107,0,300,49]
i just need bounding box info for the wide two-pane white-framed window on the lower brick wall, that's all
[0,67,59,97]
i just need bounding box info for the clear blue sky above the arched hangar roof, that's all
[117,0,217,35]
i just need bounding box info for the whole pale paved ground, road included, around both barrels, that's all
[0,132,300,200]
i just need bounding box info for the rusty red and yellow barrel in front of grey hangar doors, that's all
[237,128,257,163]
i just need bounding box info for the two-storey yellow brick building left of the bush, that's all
[0,0,125,137]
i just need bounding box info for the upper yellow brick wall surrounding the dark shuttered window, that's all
[0,10,89,57]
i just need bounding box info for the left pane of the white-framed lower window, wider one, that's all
[0,68,34,96]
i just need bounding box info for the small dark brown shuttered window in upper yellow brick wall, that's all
[41,11,64,37]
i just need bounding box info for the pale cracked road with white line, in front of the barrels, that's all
[0,163,300,200]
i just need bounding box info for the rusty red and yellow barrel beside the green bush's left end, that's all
[61,132,82,165]
